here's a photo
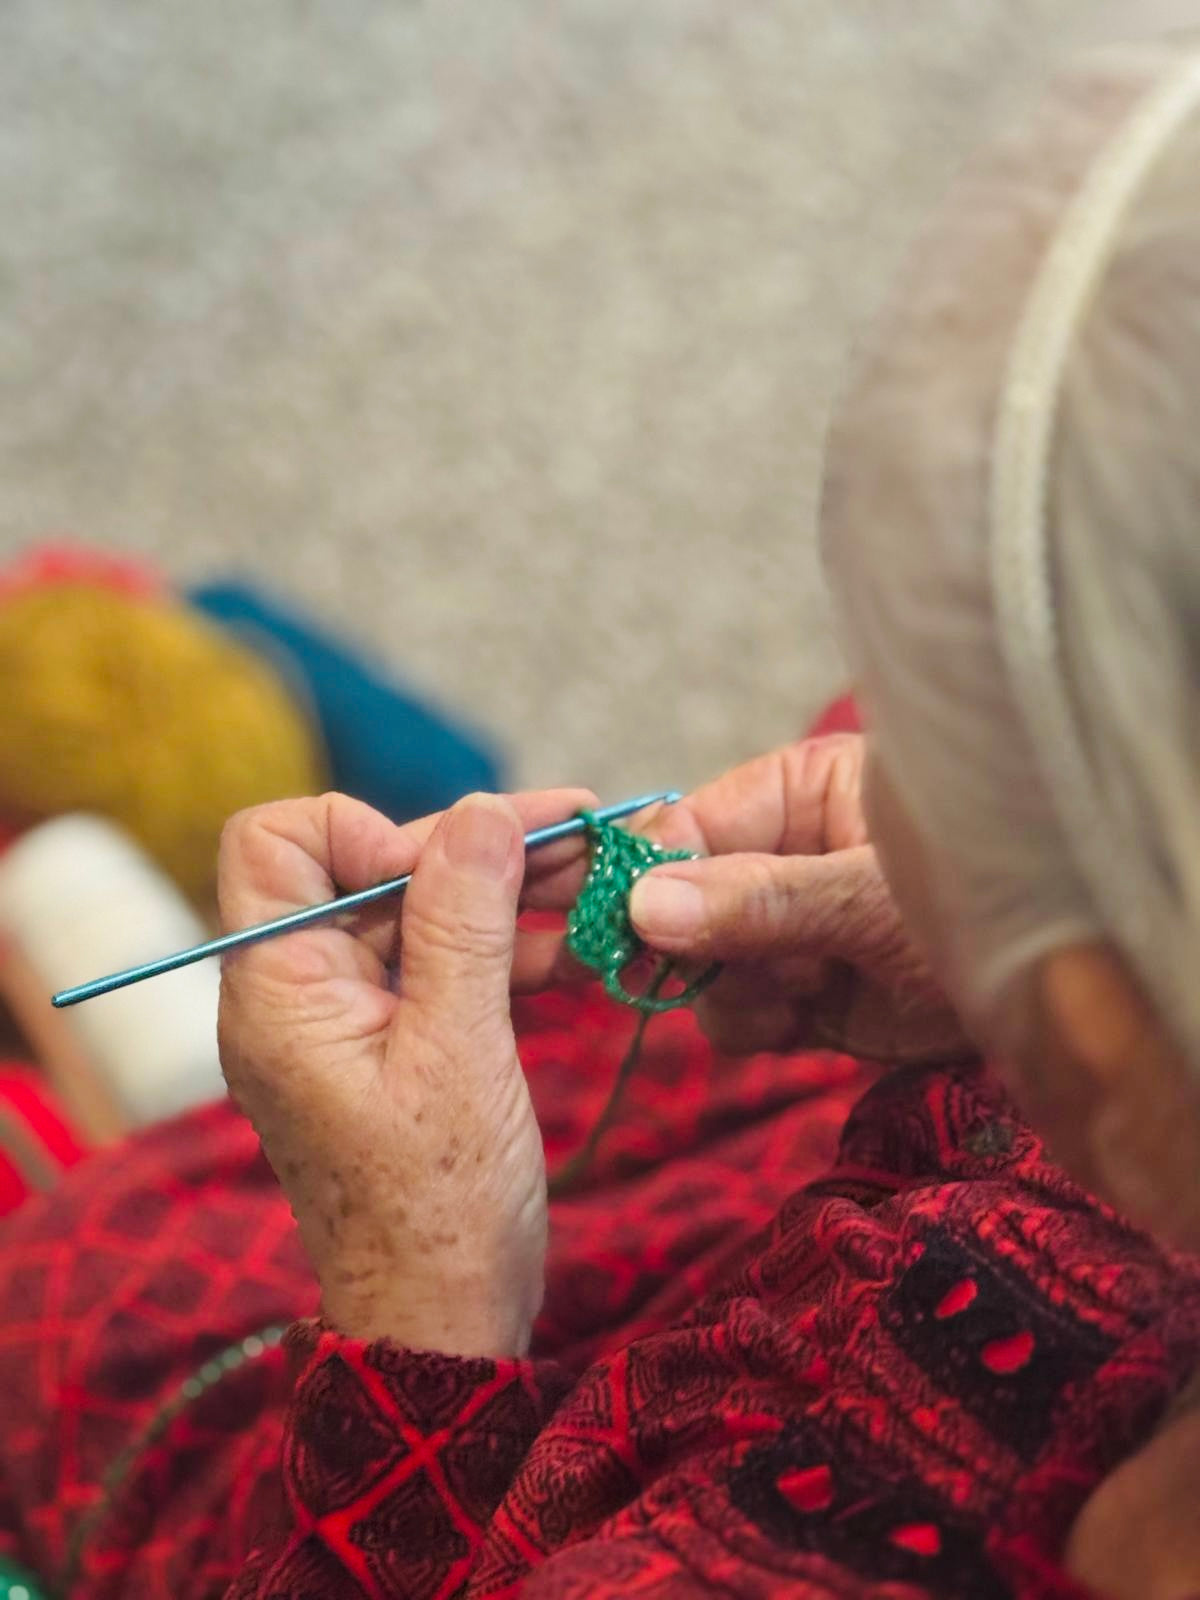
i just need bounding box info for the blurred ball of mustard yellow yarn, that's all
[0,584,323,901]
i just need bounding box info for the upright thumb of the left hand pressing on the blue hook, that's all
[400,794,525,1027]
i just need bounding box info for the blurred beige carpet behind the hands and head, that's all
[0,0,1184,797]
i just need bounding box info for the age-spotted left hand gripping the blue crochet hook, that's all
[219,789,595,1357]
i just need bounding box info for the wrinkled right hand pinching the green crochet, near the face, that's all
[520,734,971,1062]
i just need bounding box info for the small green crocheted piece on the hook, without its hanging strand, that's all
[566,811,717,1016]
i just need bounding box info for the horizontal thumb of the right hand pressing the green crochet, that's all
[629,845,896,965]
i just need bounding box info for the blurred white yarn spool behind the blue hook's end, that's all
[0,814,224,1126]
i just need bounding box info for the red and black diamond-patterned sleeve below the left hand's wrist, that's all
[227,1322,571,1600]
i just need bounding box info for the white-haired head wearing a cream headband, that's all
[822,31,1200,1245]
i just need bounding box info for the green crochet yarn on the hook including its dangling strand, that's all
[549,811,720,1197]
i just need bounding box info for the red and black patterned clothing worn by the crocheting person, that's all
[0,990,1200,1600]
